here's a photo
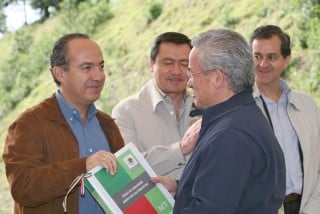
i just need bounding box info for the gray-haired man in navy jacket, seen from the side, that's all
[152,29,285,214]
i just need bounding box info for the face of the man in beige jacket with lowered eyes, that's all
[150,42,191,97]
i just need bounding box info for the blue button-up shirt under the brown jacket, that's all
[56,90,110,214]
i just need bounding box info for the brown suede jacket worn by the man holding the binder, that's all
[3,95,124,214]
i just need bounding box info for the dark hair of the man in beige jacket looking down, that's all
[150,32,192,61]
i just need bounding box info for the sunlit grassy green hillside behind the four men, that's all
[0,0,320,213]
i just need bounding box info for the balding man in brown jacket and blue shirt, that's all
[3,33,124,214]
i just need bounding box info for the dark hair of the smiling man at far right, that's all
[250,25,291,58]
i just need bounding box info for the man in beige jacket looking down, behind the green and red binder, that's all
[112,32,200,179]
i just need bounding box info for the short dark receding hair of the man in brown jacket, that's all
[50,33,90,86]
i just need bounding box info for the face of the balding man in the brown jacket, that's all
[55,38,105,110]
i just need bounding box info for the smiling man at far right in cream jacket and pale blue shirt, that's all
[250,25,320,214]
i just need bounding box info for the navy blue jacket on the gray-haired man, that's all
[174,90,285,214]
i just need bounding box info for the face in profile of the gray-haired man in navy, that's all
[188,48,216,108]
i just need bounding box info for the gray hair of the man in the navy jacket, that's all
[191,29,254,93]
